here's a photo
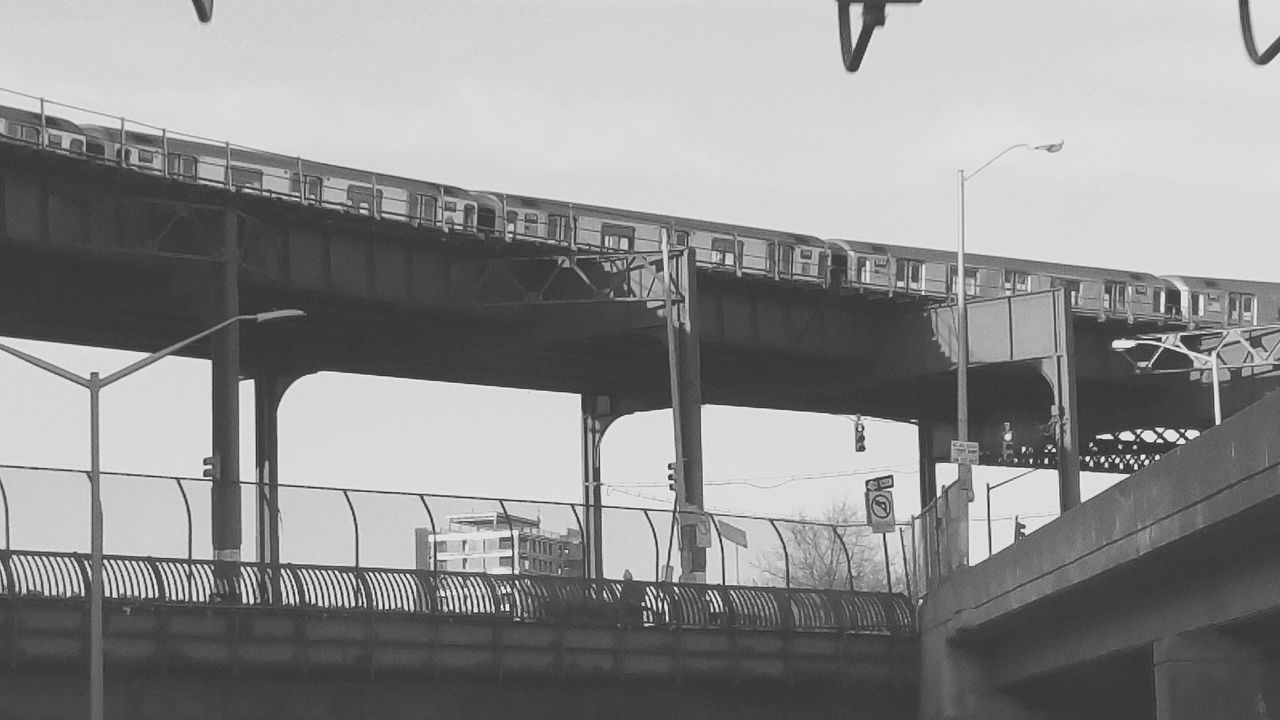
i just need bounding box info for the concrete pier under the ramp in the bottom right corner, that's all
[1152,630,1280,720]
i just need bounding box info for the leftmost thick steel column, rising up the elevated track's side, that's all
[210,206,242,602]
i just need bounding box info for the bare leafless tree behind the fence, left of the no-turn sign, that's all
[756,498,887,591]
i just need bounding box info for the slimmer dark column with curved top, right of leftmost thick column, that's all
[253,373,298,605]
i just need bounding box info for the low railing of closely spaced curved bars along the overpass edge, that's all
[0,551,915,635]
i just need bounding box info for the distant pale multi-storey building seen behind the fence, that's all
[413,512,582,578]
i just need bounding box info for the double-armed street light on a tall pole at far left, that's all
[0,310,306,720]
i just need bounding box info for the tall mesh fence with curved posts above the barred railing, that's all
[0,465,914,593]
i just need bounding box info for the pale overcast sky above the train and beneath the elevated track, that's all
[0,0,1280,571]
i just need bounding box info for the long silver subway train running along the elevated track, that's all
[0,101,1280,329]
